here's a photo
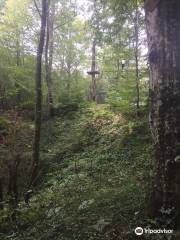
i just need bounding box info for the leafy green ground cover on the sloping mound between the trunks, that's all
[0,105,163,240]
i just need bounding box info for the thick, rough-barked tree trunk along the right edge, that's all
[145,0,180,215]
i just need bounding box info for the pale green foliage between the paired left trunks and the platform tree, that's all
[53,15,89,103]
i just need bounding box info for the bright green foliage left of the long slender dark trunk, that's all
[0,0,36,109]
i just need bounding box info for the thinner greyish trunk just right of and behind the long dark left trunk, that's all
[45,2,55,117]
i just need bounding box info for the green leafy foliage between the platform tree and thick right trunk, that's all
[91,0,147,112]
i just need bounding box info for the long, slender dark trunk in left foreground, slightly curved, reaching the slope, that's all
[30,0,48,185]
